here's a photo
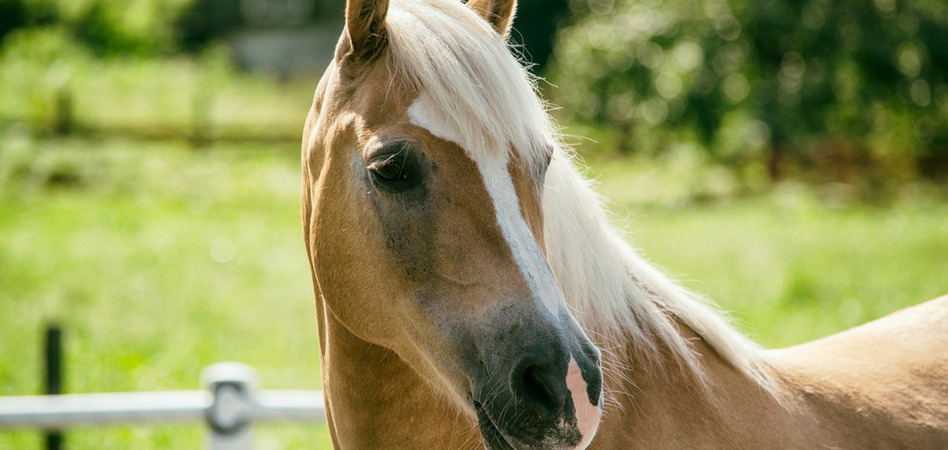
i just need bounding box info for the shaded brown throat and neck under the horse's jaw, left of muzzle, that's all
[317,302,482,448]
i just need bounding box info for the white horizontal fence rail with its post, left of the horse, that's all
[0,363,326,450]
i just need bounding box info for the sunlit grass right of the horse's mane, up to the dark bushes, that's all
[590,155,948,347]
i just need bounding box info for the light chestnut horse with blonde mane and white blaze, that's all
[302,0,948,449]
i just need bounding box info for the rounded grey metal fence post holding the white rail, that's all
[201,362,257,450]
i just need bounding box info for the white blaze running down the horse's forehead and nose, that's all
[408,93,564,314]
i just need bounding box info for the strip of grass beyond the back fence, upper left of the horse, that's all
[0,34,319,141]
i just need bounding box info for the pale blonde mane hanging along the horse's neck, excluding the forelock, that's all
[543,158,766,383]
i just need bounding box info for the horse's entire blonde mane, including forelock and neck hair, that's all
[388,0,770,388]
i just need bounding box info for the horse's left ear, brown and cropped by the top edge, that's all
[346,0,389,60]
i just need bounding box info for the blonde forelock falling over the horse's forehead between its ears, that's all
[387,0,559,171]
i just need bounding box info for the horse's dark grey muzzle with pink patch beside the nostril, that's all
[471,308,602,450]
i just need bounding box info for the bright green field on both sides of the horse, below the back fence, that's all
[0,133,948,449]
